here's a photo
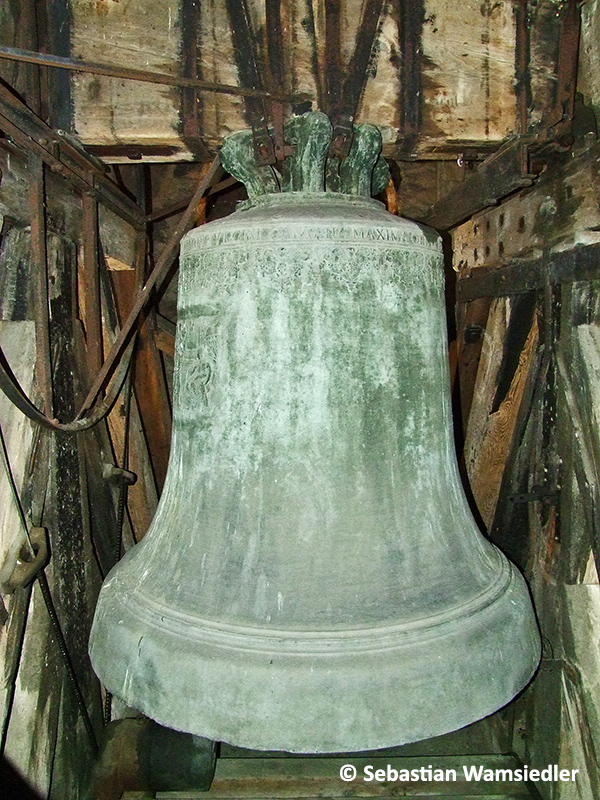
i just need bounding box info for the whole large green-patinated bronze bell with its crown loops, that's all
[90,113,540,753]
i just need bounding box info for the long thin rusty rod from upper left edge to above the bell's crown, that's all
[0,47,294,101]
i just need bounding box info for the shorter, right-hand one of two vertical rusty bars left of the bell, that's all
[81,192,102,375]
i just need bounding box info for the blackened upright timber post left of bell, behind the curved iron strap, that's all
[42,237,100,796]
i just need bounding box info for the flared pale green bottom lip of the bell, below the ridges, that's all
[90,565,541,753]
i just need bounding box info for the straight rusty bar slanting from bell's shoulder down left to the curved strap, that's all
[78,157,221,417]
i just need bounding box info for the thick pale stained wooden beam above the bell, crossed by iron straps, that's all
[63,0,560,160]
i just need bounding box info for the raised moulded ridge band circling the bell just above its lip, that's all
[92,551,514,656]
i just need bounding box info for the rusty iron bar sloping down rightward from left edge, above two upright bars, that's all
[0,84,145,228]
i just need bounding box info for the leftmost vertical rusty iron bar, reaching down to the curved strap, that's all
[29,153,53,416]
